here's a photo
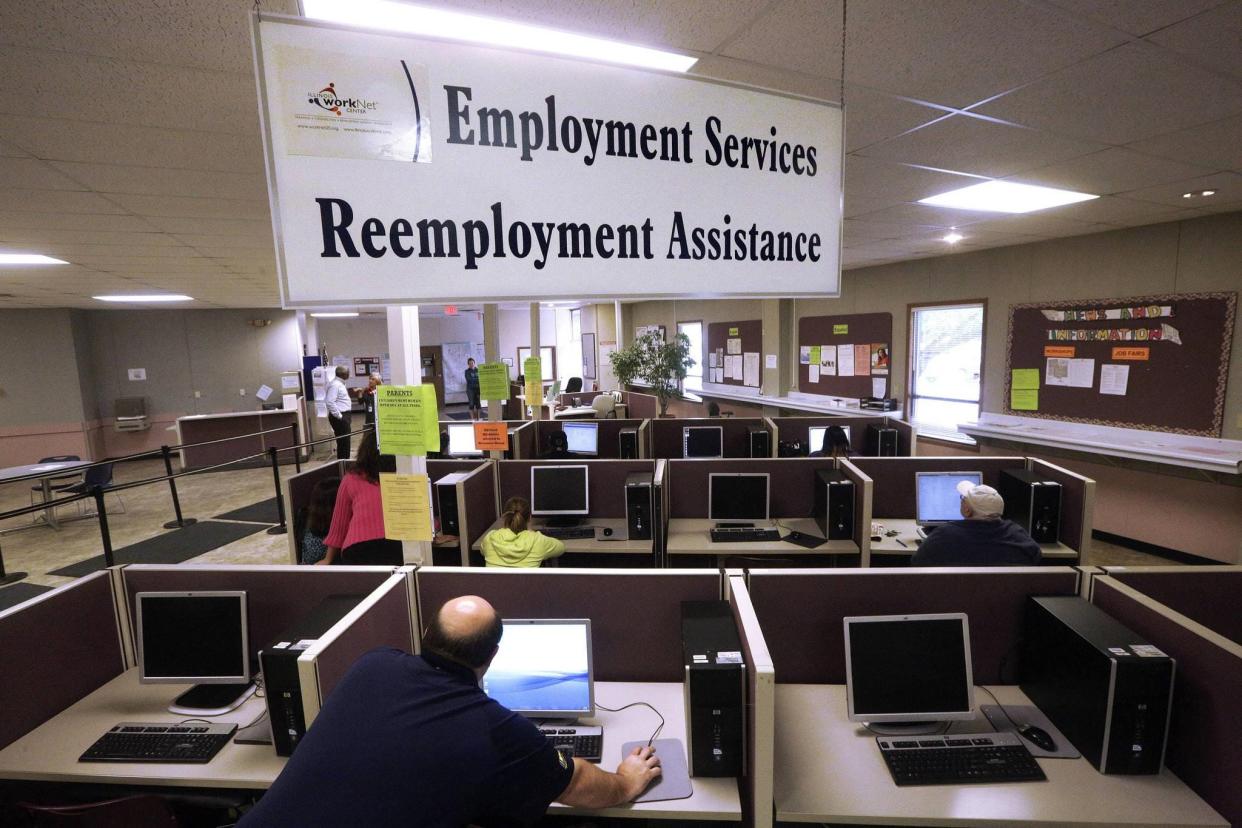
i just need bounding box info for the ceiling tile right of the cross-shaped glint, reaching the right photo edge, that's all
[976,43,1242,144]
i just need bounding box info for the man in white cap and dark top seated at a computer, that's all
[910,480,1041,566]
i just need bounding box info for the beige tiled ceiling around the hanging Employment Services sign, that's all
[0,0,1242,308]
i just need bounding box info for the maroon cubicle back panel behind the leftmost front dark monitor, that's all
[120,564,392,663]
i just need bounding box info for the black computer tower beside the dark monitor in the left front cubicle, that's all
[258,595,365,756]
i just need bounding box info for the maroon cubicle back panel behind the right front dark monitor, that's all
[746,566,1079,684]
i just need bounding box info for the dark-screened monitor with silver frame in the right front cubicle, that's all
[845,612,974,722]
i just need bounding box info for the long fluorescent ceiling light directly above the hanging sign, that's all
[302,0,698,72]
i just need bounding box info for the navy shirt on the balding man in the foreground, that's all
[240,648,574,828]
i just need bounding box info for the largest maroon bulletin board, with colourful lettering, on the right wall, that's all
[1005,293,1237,437]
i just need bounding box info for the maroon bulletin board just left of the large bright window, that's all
[797,313,893,398]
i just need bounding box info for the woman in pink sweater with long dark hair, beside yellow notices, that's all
[319,431,402,566]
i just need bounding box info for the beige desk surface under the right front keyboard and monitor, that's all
[774,684,1228,827]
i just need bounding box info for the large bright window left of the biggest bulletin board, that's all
[910,302,986,438]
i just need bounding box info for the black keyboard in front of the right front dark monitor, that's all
[876,734,1048,786]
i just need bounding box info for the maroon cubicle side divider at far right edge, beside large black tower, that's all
[1090,572,1242,826]
